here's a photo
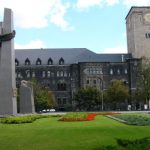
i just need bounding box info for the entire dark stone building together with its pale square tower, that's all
[15,7,150,110]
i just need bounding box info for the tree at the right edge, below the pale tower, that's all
[137,57,150,108]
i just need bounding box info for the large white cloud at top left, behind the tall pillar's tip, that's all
[0,0,72,30]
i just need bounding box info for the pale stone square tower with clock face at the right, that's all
[126,7,150,58]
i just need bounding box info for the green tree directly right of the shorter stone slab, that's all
[32,80,56,111]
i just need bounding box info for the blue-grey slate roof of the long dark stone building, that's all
[15,48,131,65]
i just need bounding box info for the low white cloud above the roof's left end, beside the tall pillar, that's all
[15,40,46,49]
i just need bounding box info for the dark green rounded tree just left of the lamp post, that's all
[74,87,101,110]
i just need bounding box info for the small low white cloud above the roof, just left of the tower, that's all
[102,46,127,54]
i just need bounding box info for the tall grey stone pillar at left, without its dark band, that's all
[0,8,17,115]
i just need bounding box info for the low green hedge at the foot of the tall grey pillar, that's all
[0,115,48,124]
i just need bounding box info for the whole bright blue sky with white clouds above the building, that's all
[0,0,150,53]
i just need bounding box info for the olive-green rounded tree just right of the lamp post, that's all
[106,80,129,109]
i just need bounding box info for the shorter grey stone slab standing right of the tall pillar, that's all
[20,80,35,114]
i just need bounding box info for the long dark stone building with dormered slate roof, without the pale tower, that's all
[15,48,135,110]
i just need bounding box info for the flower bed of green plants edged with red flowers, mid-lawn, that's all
[59,113,97,122]
